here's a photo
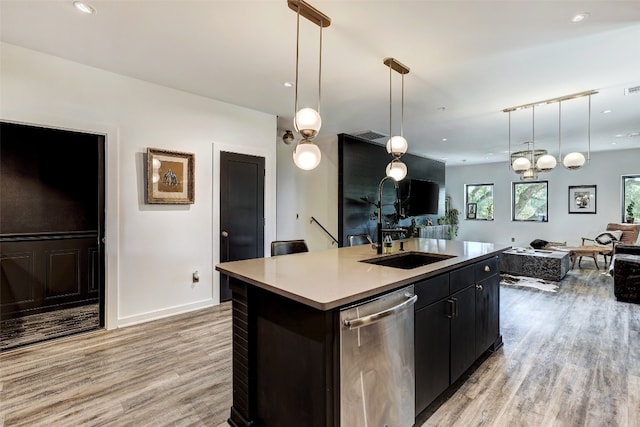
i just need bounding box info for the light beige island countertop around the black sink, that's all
[216,238,511,310]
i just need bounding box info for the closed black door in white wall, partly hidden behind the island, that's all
[220,151,265,301]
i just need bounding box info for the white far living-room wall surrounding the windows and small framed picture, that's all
[446,149,640,246]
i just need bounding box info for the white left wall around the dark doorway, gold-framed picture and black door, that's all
[0,43,277,328]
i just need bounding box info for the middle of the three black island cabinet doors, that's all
[450,285,476,383]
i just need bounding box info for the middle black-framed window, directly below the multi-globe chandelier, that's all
[512,181,549,222]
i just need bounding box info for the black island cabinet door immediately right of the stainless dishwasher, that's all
[414,299,450,415]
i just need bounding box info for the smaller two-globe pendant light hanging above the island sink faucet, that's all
[383,58,409,181]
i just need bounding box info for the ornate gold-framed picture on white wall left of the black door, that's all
[146,147,195,205]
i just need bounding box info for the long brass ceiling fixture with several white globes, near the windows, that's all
[502,90,598,180]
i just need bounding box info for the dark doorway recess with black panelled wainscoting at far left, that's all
[0,122,105,325]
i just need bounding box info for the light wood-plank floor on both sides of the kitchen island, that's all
[0,262,640,427]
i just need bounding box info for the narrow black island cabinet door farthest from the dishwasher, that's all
[475,275,500,357]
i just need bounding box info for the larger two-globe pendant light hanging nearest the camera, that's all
[287,0,331,170]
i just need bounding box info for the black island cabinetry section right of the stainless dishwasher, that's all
[415,257,502,414]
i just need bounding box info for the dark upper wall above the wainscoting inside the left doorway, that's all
[0,123,101,234]
